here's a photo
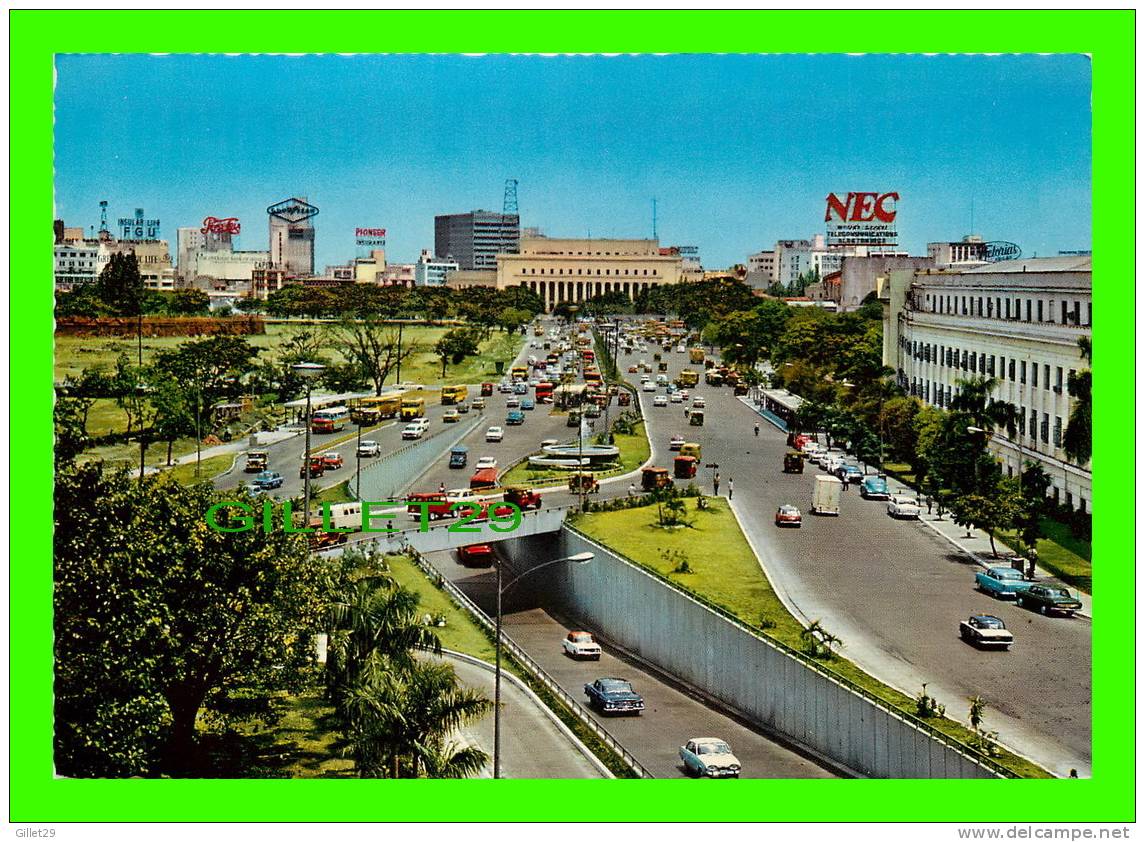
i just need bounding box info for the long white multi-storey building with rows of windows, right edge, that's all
[879,257,1092,510]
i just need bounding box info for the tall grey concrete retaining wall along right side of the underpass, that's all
[502,528,996,778]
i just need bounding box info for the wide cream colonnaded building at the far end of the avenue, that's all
[496,237,685,310]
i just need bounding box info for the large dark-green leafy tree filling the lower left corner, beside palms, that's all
[53,464,324,777]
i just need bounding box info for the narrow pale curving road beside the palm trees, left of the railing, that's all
[430,658,605,779]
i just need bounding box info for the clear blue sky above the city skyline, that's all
[55,55,1091,270]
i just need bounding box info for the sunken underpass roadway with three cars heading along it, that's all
[427,552,836,778]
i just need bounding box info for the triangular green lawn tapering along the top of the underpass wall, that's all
[575,498,1051,778]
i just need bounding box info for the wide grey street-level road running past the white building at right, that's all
[622,343,1092,777]
